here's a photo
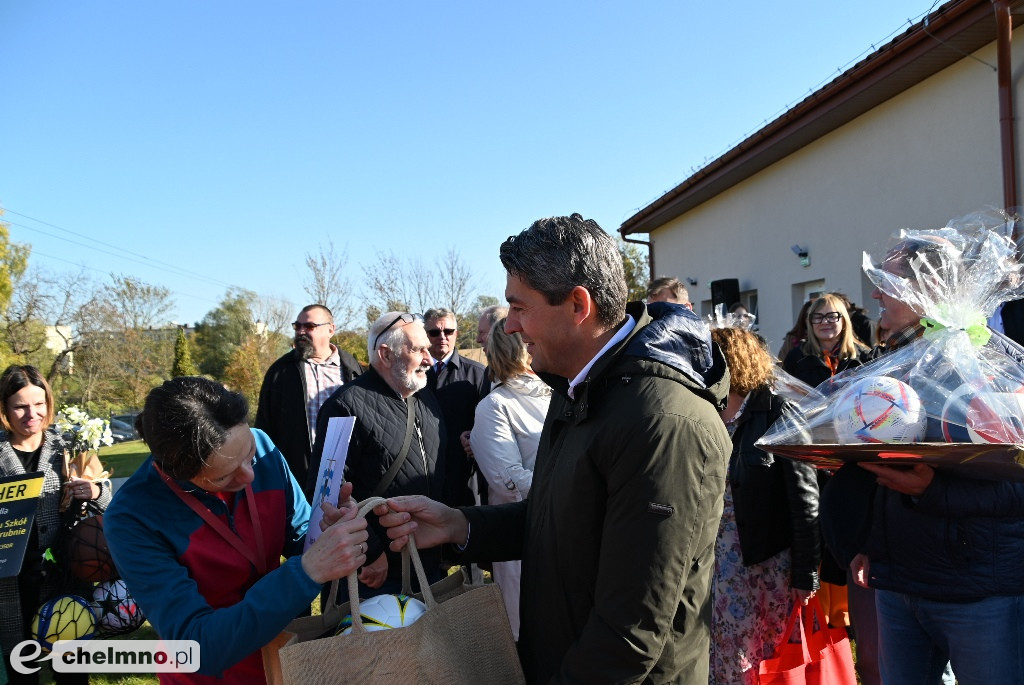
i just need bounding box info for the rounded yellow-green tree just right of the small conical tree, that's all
[196,288,258,380]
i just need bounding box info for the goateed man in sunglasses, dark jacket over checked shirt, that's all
[256,304,362,483]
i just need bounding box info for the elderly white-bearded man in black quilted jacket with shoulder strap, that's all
[305,311,446,601]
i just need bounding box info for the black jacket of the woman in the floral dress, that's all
[729,388,821,590]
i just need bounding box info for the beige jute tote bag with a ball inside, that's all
[267,498,525,685]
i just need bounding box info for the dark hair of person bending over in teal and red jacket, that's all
[135,376,249,480]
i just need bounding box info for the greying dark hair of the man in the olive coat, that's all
[501,214,627,328]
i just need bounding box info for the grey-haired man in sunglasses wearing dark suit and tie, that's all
[423,307,490,505]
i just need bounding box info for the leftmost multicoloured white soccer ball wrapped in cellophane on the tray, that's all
[833,376,928,444]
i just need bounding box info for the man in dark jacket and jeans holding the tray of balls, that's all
[821,237,1024,685]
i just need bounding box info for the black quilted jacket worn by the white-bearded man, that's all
[305,367,446,580]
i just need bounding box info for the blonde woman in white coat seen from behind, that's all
[470,318,551,640]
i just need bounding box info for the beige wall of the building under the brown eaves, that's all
[650,31,1024,350]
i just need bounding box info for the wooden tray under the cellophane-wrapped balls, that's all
[761,442,1024,480]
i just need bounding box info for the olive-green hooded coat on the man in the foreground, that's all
[463,302,731,685]
